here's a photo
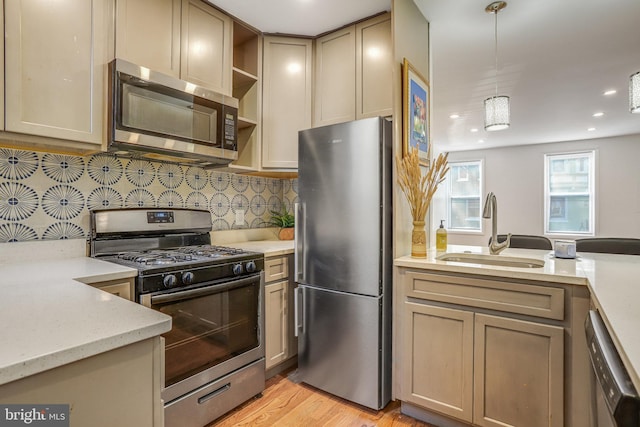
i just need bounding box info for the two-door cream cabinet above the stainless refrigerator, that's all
[313,13,393,126]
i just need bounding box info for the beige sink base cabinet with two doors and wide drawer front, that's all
[396,269,589,427]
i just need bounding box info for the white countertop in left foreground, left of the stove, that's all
[0,258,171,385]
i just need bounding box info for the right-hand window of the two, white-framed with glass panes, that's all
[544,151,595,235]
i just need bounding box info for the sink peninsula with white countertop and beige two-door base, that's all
[394,245,640,426]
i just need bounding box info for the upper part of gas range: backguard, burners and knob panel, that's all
[90,208,264,299]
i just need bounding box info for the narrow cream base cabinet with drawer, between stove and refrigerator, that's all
[264,255,297,370]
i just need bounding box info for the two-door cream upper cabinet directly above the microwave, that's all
[116,0,233,95]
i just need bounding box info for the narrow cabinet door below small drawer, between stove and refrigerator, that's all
[264,280,289,369]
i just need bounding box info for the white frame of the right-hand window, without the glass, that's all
[543,150,597,236]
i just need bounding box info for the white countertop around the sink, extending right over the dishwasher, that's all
[394,245,640,390]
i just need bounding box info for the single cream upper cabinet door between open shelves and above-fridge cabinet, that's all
[262,37,312,169]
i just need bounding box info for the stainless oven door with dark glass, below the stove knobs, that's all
[140,273,264,402]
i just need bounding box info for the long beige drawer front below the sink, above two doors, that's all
[406,272,564,320]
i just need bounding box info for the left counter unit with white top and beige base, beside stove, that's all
[0,241,171,427]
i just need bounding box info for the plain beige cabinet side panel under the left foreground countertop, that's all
[0,337,164,427]
